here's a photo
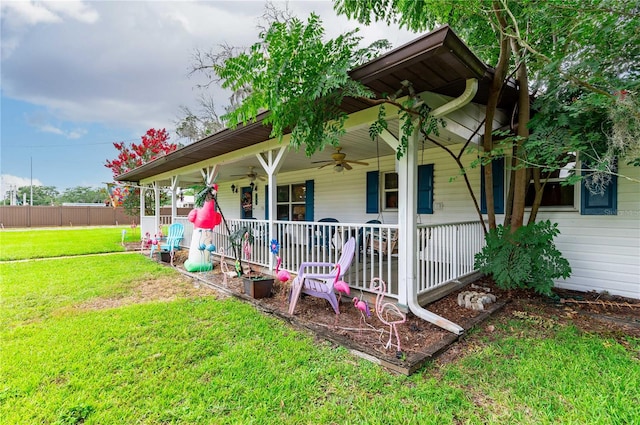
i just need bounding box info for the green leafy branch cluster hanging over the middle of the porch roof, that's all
[214,14,387,155]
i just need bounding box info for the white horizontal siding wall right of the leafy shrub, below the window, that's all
[538,162,640,298]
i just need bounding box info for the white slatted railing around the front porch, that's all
[154,217,484,299]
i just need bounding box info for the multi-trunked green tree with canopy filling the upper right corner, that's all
[335,0,640,231]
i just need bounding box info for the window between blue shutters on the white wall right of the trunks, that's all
[525,153,576,208]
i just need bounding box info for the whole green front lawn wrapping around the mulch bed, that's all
[0,229,640,424]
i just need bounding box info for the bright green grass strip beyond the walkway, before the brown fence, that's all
[0,226,140,261]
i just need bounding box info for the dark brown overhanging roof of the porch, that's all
[116,25,517,183]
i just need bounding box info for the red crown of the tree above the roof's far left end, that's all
[104,128,178,179]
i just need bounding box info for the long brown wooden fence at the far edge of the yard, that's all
[0,205,190,228]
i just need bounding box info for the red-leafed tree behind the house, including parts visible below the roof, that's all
[104,128,178,216]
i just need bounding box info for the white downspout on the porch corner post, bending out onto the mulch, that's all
[405,78,478,335]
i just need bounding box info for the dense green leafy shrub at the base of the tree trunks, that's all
[475,220,571,295]
